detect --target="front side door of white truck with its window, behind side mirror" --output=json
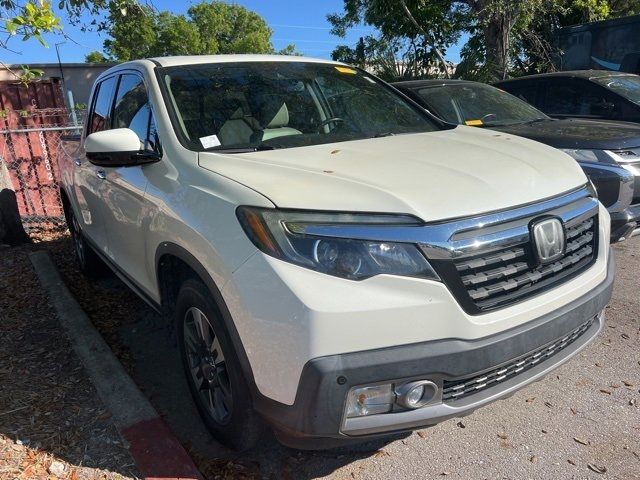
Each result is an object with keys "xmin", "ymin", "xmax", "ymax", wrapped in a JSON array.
[{"xmin": 102, "ymin": 71, "xmax": 162, "ymax": 293}]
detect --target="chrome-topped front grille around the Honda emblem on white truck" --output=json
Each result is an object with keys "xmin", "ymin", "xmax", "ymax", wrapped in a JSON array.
[{"xmin": 425, "ymin": 191, "xmax": 598, "ymax": 315}]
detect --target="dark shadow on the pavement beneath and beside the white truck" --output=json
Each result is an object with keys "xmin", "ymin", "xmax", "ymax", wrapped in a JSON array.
[{"xmin": 40, "ymin": 237, "xmax": 402, "ymax": 479}]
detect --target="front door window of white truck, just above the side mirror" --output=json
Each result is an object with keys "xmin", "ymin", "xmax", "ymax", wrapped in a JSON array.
[{"xmin": 113, "ymin": 74, "xmax": 159, "ymax": 152}]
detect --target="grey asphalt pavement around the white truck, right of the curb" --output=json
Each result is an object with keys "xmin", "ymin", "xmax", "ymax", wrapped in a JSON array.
[{"xmin": 43, "ymin": 234, "xmax": 640, "ymax": 479}]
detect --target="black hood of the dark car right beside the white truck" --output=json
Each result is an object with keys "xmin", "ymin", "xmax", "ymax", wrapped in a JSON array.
[{"xmin": 488, "ymin": 118, "xmax": 640, "ymax": 150}]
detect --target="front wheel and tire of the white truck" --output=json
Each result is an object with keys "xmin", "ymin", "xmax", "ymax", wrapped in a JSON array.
[{"xmin": 175, "ymin": 280, "xmax": 263, "ymax": 451}]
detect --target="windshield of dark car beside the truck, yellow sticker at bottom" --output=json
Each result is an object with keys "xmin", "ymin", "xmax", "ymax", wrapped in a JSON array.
[{"xmin": 416, "ymin": 83, "xmax": 549, "ymax": 127}]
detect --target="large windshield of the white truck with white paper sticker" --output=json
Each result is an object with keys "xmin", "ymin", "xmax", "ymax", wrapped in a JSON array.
[{"xmin": 162, "ymin": 62, "xmax": 442, "ymax": 152}]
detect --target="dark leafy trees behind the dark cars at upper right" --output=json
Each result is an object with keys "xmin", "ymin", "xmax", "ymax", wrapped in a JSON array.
[{"xmin": 328, "ymin": 0, "xmax": 640, "ymax": 81}]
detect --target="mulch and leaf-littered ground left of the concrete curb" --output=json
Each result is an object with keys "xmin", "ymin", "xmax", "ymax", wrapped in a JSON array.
[{"xmin": 0, "ymin": 240, "xmax": 137, "ymax": 480}]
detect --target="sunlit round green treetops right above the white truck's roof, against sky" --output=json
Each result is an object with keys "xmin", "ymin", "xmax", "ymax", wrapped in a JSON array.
[{"xmin": 104, "ymin": 1, "xmax": 288, "ymax": 61}]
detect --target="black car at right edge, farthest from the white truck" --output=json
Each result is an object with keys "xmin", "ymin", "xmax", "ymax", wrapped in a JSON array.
[{"xmin": 495, "ymin": 70, "xmax": 640, "ymax": 123}]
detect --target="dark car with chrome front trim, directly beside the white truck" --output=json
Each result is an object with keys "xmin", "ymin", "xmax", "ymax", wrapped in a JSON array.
[{"xmin": 394, "ymin": 80, "xmax": 640, "ymax": 242}]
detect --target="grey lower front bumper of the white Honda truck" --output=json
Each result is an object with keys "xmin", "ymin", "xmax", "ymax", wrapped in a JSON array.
[{"xmin": 254, "ymin": 255, "xmax": 615, "ymax": 448}]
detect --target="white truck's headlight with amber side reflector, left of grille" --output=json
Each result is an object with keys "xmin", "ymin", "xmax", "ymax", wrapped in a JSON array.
[{"xmin": 237, "ymin": 207, "xmax": 439, "ymax": 280}]
